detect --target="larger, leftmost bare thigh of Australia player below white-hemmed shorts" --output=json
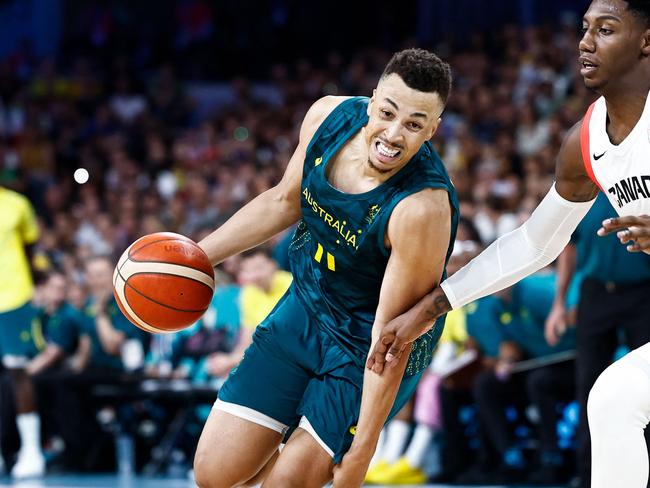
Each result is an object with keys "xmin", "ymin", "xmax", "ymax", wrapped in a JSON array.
[{"xmin": 194, "ymin": 409, "xmax": 282, "ymax": 488}]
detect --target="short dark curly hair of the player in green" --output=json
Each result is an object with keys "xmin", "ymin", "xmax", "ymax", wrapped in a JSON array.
[{"xmin": 381, "ymin": 48, "xmax": 451, "ymax": 103}]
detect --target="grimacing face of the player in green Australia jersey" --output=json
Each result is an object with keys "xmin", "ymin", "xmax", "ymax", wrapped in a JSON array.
[{"xmin": 365, "ymin": 74, "xmax": 444, "ymax": 173}]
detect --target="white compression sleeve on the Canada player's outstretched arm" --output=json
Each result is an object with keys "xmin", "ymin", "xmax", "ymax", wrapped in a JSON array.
[{"xmin": 440, "ymin": 184, "xmax": 595, "ymax": 308}]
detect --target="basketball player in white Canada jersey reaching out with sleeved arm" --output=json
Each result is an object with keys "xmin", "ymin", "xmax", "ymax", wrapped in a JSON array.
[{"xmin": 368, "ymin": 0, "xmax": 650, "ymax": 488}]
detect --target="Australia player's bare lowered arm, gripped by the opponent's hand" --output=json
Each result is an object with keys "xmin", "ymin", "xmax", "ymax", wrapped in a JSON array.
[{"xmin": 334, "ymin": 190, "xmax": 451, "ymax": 488}]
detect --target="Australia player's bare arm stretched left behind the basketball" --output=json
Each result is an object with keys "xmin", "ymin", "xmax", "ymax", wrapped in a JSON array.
[{"xmin": 199, "ymin": 97, "xmax": 346, "ymax": 265}]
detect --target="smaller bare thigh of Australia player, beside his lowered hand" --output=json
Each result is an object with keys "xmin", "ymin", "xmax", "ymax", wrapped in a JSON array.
[{"xmin": 262, "ymin": 428, "xmax": 334, "ymax": 488}]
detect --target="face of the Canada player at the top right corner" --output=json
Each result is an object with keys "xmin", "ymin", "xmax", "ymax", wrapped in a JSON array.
[{"xmin": 579, "ymin": 0, "xmax": 650, "ymax": 91}]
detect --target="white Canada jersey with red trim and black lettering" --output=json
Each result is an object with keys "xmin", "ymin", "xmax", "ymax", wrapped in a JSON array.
[{"xmin": 580, "ymin": 96, "xmax": 650, "ymax": 215}]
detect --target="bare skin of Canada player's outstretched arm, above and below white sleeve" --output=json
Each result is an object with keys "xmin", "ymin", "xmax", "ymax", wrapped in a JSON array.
[{"xmin": 366, "ymin": 121, "xmax": 596, "ymax": 374}]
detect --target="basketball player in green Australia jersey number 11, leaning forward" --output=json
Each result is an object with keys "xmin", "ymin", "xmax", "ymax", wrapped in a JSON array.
[{"xmin": 194, "ymin": 49, "xmax": 458, "ymax": 488}]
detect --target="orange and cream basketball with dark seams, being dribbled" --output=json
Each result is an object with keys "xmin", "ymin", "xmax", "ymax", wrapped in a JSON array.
[{"xmin": 113, "ymin": 232, "xmax": 214, "ymax": 333}]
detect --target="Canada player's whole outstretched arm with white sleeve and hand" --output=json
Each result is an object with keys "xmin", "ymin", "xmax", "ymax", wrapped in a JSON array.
[{"xmin": 368, "ymin": 122, "xmax": 598, "ymax": 373}]
